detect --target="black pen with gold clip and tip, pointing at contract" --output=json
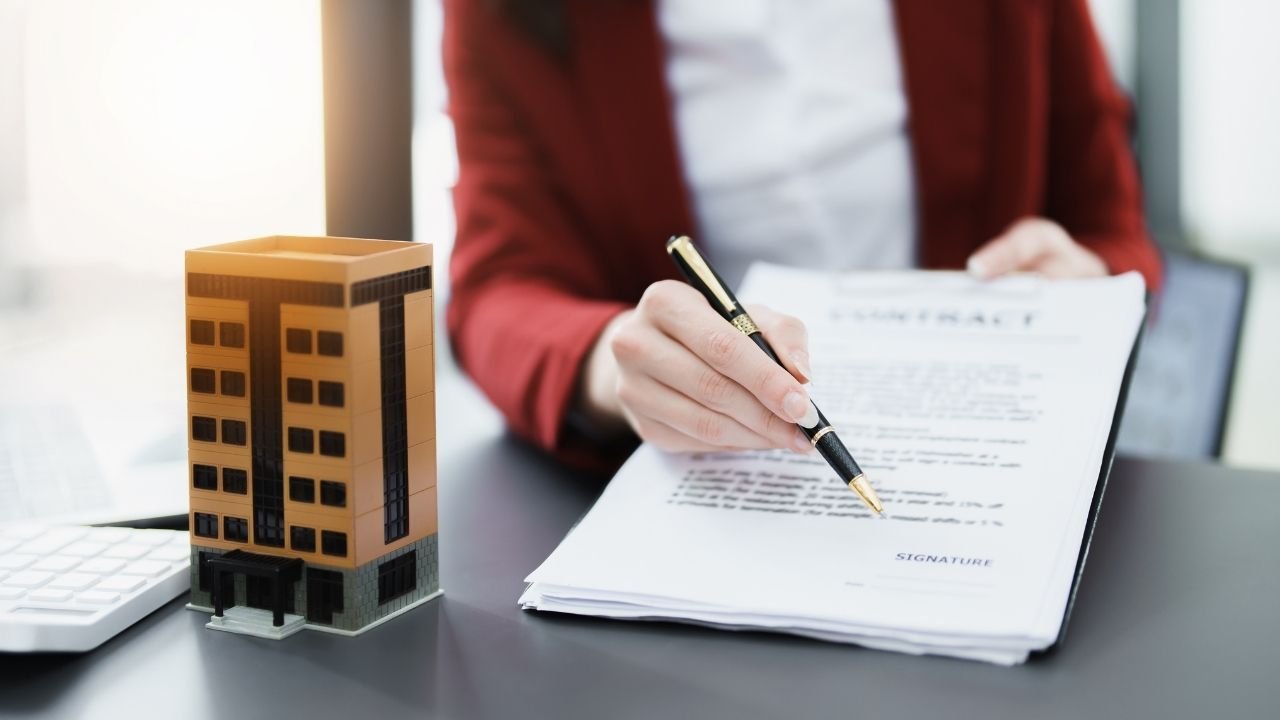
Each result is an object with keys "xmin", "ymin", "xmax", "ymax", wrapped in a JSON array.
[{"xmin": 667, "ymin": 236, "xmax": 884, "ymax": 514}]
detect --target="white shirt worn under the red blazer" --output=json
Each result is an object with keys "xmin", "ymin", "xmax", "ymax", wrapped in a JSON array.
[{"xmin": 658, "ymin": 0, "xmax": 915, "ymax": 286}]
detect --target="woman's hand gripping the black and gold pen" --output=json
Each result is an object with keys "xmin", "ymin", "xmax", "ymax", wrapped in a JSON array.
[{"xmin": 579, "ymin": 281, "xmax": 817, "ymax": 452}]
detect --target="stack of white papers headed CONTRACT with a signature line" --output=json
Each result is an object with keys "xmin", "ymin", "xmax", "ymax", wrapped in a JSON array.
[{"xmin": 520, "ymin": 265, "xmax": 1146, "ymax": 665}]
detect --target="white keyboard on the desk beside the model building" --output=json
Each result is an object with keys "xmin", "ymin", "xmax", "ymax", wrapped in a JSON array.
[{"xmin": 0, "ymin": 524, "xmax": 191, "ymax": 652}]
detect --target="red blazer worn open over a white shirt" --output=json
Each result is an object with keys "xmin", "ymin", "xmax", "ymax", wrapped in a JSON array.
[{"xmin": 444, "ymin": 0, "xmax": 1160, "ymax": 464}]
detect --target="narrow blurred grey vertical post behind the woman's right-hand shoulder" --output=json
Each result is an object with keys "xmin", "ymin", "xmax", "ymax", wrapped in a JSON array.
[{"xmin": 1134, "ymin": 0, "xmax": 1187, "ymax": 249}]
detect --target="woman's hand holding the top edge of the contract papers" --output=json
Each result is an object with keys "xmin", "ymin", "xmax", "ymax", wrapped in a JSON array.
[{"xmin": 968, "ymin": 218, "xmax": 1107, "ymax": 279}]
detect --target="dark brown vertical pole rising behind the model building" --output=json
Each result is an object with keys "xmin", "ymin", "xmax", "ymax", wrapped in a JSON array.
[{"xmin": 320, "ymin": 0, "xmax": 413, "ymax": 240}]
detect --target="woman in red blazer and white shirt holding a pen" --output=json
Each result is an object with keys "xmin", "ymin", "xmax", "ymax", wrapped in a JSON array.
[{"xmin": 444, "ymin": 0, "xmax": 1160, "ymax": 465}]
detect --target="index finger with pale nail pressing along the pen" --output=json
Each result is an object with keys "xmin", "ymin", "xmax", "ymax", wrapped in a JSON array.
[{"xmin": 637, "ymin": 282, "xmax": 817, "ymax": 427}]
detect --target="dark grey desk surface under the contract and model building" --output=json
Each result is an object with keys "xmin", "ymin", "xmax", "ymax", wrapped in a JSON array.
[{"xmin": 0, "ymin": 371, "xmax": 1280, "ymax": 720}]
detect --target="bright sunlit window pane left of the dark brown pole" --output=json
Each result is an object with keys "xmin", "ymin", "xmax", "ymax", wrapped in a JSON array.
[{"xmin": 10, "ymin": 0, "xmax": 325, "ymax": 274}]
